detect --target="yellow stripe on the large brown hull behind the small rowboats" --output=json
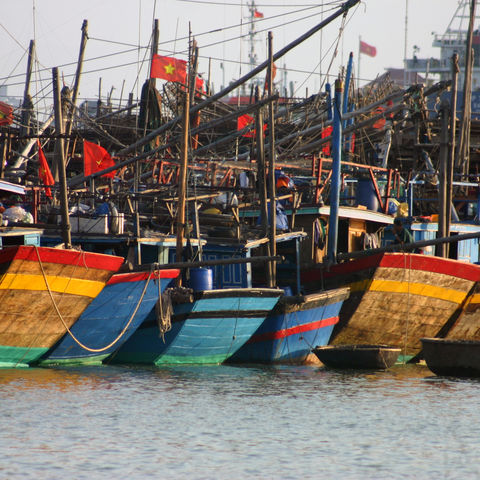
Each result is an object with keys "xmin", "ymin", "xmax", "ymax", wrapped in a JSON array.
[{"xmin": 349, "ymin": 280, "xmax": 467, "ymax": 303}]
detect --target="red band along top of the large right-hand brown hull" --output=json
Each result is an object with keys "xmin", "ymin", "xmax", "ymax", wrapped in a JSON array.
[{"xmin": 302, "ymin": 253, "xmax": 480, "ymax": 282}]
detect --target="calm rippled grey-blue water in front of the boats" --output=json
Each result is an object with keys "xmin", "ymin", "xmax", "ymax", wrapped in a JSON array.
[{"xmin": 0, "ymin": 366, "xmax": 480, "ymax": 480}]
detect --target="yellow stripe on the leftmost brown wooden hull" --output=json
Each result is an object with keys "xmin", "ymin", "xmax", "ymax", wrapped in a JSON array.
[{"xmin": 0, "ymin": 273, "xmax": 104, "ymax": 298}]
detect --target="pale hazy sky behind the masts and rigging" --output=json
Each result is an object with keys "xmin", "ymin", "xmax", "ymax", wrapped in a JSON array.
[{"xmin": 0, "ymin": 0, "xmax": 470, "ymax": 110}]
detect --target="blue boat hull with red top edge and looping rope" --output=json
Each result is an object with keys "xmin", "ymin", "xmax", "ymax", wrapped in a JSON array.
[{"xmin": 40, "ymin": 270, "xmax": 180, "ymax": 366}]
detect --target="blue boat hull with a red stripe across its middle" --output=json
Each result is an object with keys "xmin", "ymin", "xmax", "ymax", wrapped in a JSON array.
[{"xmin": 228, "ymin": 288, "xmax": 349, "ymax": 364}]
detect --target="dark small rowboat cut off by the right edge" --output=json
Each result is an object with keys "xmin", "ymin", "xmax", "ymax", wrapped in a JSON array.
[{"xmin": 422, "ymin": 338, "xmax": 480, "ymax": 377}]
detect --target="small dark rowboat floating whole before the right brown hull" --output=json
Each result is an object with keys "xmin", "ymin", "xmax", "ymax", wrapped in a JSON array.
[{"xmin": 313, "ymin": 345, "xmax": 401, "ymax": 370}]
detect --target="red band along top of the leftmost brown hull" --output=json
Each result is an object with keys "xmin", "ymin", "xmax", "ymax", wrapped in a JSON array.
[{"xmin": 0, "ymin": 245, "xmax": 124, "ymax": 272}]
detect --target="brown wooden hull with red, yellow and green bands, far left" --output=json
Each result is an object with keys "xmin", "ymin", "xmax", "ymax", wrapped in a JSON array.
[{"xmin": 0, "ymin": 246, "xmax": 123, "ymax": 367}]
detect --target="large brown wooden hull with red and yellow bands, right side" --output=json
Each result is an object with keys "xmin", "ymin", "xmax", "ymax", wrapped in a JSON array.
[{"xmin": 304, "ymin": 253, "xmax": 480, "ymax": 358}]
